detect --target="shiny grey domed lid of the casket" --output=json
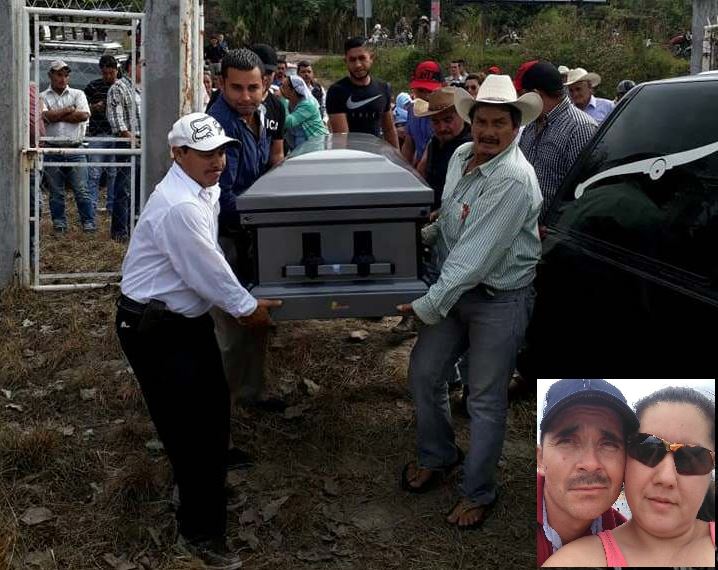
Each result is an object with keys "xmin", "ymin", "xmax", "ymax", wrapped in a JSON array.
[{"xmin": 237, "ymin": 133, "xmax": 434, "ymax": 212}]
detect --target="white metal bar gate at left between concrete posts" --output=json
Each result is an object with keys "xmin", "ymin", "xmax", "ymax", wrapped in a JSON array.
[{"xmin": 21, "ymin": 6, "xmax": 146, "ymax": 290}]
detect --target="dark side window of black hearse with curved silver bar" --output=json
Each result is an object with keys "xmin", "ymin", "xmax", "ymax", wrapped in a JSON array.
[{"xmin": 551, "ymin": 81, "xmax": 718, "ymax": 290}]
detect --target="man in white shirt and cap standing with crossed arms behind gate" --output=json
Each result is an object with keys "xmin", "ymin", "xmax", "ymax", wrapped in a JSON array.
[{"xmin": 40, "ymin": 59, "xmax": 96, "ymax": 234}]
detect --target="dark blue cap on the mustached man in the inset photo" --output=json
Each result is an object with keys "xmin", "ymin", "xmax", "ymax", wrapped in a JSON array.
[{"xmin": 541, "ymin": 378, "xmax": 640, "ymax": 435}]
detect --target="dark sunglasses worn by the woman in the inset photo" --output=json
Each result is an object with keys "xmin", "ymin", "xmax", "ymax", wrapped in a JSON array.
[{"xmin": 626, "ymin": 433, "xmax": 715, "ymax": 475}]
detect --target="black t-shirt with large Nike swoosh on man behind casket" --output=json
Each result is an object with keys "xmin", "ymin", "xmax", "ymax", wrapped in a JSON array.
[{"xmin": 327, "ymin": 77, "xmax": 391, "ymax": 137}]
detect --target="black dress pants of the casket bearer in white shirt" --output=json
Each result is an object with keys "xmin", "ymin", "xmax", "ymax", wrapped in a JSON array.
[{"xmin": 115, "ymin": 307, "xmax": 230, "ymax": 541}]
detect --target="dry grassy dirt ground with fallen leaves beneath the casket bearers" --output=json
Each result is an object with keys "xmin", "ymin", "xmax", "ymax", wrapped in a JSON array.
[{"xmin": 0, "ymin": 193, "xmax": 536, "ymax": 570}]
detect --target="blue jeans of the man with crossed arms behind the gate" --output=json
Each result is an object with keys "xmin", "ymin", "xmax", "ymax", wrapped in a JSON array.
[{"xmin": 44, "ymin": 154, "xmax": 95, "ymax": 229}]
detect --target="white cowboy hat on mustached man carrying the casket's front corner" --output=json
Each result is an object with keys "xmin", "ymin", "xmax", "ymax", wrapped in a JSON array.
[{"xmin": 454, "ymin": 75, "xmax": 543, "ymax": 125}]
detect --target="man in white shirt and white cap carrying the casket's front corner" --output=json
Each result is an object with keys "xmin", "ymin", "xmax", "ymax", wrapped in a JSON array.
[{"xmin": 115, "ymin": 113, "xmax": 281, "ymax": 569}]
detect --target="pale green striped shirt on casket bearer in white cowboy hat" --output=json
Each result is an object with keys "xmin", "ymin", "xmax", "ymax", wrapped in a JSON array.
[{"xmin": 412, "ymin": 140, "xmax": 541, "ymax": 325}]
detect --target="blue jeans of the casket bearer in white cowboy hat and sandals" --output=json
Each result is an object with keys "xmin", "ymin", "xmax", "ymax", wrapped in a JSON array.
[{"xmin": 409, "ymin": 286, "xmax": 534, "ymax": 505}]
